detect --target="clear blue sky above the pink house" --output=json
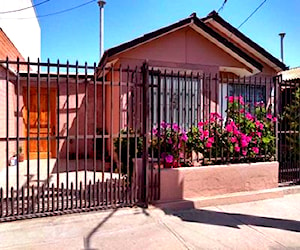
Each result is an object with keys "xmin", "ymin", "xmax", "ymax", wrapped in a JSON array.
[{"xmin": 33, "ymin": 0, "xmax": 300, "ymax": 67}]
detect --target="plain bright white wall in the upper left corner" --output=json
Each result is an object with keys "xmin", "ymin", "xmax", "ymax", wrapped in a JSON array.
[{"xmin": 0, "ymin": 0, "xmax": 41, "ymax": 61}]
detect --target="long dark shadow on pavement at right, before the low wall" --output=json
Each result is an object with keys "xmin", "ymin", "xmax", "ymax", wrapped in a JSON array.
[{"xmin": 165, "ymin": 209, "xmax": 300, "ymax": 233}]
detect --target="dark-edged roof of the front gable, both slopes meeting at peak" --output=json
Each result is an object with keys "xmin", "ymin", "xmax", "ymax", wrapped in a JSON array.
[{"xmin": 99, "ymin": 13, "xmax": 263, "ymax": 71}]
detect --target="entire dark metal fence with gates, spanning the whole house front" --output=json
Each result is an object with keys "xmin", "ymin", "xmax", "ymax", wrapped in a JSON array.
[{"xmin": 0, "ymin": 60, "xmax": 299, "ymax": 220}]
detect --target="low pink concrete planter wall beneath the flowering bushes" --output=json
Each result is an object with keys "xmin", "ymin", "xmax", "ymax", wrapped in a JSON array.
[{"xmin": 160, "ymin": 162, "xmax": 279, "ymax": 201}]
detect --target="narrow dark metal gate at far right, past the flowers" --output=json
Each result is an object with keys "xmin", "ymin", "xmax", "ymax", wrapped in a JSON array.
[{"xmin": 275, "ymin": 75, "xmax": 300, "ymax": 184}]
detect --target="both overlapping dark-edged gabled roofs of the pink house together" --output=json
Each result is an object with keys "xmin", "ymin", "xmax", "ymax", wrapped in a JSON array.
[{"xmin": 99, "ymin": 11, "xmax": 286, "ymax": 71}]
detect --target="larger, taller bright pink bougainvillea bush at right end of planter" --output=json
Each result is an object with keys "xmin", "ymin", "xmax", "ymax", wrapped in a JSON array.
[{"xmin": 222, "ymin": 96, "xmax": 276, "ymax": 160}]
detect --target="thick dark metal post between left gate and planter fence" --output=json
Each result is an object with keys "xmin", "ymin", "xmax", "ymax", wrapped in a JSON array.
[{"xmin": 141, "ymin": 62, "xmax": 149, "ymax": 207}]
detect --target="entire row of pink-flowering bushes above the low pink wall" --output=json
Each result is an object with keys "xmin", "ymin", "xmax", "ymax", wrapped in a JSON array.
[{"xmin": 151, "ymin": 96, "xmax": 276, "ymax": 168}]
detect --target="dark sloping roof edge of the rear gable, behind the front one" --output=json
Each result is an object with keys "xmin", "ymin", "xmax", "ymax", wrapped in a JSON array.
[{"xmin": 201, "ymin": 11, "xmax": 287, "ymax": 70}]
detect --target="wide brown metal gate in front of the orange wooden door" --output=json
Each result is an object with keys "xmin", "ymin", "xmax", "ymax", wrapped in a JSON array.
[{"xmin": 0, "ymin": 59, "xmax": 147, "ymax": 221}]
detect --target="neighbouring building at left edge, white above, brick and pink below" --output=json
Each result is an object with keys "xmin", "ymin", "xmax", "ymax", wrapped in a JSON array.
[{"xmin": 0, "ymin": 0, "xmax": 41, "ymax": 170}]
